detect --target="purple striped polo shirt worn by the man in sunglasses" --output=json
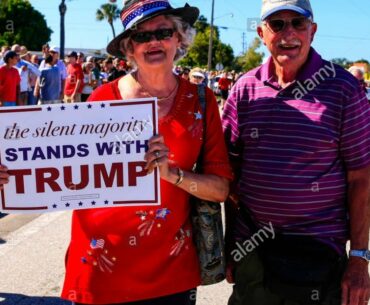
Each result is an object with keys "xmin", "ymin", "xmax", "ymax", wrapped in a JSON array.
[{"xmin": 223, "ymin": 49, "xmax": 370, "ymax": 251}]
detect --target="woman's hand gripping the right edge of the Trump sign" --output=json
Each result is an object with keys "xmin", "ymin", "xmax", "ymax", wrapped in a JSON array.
[{"xmin": 144, "ymin": 135, "xmax": 171, "ymax": 180}]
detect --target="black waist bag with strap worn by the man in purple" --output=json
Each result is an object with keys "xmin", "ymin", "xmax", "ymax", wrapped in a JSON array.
[{"xmin": 239, "ymin": 205, "xmax": 347, "ymax": 305}]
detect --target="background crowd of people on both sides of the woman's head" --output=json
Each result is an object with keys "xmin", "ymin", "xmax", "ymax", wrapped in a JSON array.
[{"xmin": 0, "ymin": 44, "xmax": 242, "ymax": 107}]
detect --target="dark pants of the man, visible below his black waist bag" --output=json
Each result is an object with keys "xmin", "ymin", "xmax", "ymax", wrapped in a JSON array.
[{"xmin": 228, "ymin": 251, "xmax": 341, "ymax": 305}]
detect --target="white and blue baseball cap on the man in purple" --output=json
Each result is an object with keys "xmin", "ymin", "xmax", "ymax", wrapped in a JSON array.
[{"xmin": 261, "ymin": 0, "xmax": 313, "ymax": 20}]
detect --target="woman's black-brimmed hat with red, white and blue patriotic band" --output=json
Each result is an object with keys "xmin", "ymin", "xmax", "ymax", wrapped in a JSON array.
[{"xmin": 107, "ymin": 0, "xmax": 199, "ymax": 56}]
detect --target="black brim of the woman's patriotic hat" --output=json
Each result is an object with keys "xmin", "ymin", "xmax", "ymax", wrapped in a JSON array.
[{"xmin": 107, "ymin": 6, "xmax": 199, "ymax": 57}]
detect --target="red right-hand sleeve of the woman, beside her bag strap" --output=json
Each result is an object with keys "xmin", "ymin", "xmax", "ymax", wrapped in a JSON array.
[{"xmin": 203, "ymin": 88, "xmax": 233, "ymax": 180}]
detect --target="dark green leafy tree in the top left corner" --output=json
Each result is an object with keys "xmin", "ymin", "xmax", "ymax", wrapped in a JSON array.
[{"xmin": 0, "ymin": 0, "xmax": 53, "ymax": 50}]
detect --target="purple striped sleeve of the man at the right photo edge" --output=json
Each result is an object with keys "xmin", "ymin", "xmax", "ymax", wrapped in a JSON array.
[{"xmin": 340, "ymin": 84, "xmax": 370, "ymax": 170}]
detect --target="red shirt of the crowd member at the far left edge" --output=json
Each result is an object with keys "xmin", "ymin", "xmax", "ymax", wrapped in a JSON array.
[{"xmin": 0, "ymin": 65, "xmax": 21, "ymax": 102}]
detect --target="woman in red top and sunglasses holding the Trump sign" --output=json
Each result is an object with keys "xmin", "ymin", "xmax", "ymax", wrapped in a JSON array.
[{"xmin": 0, "ymin": 0, "xmax": 231, "ymax": 305}]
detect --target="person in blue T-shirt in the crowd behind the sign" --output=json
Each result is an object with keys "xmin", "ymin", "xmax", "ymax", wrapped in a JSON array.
[{"xmin": 34, "ymin": 53, "xmax": 61, "ymax": 105}]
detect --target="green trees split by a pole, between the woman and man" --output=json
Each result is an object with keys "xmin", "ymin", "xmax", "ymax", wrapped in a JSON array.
[{"xmin": 179, "ymin": 16, "xmax": 234, "ymax": 67}]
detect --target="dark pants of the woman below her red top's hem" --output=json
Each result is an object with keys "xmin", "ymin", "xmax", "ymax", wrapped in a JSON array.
[{"xmin": 76, "ymin": 288, "xmax": 197, "ymax": 305}]
